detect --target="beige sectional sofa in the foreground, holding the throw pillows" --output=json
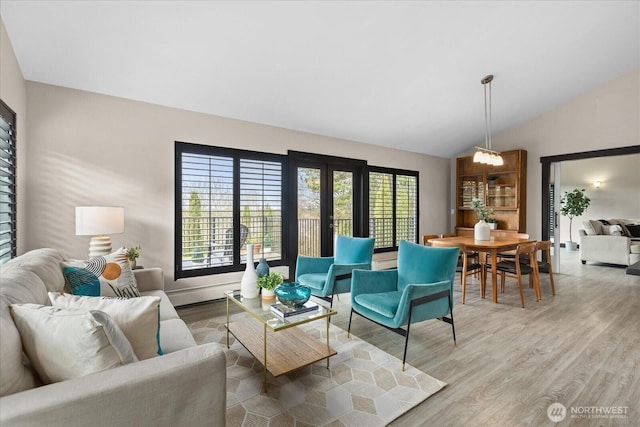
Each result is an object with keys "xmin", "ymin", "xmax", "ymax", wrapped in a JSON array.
[{"xmin": 0, "ymin": 249, "xmax": 226, "ymax": 427}]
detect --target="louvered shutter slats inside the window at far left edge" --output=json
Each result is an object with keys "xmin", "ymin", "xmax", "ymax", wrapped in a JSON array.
[{"xmin": 0, "ymin": 100, "xmax": 17, "ymax": 264}]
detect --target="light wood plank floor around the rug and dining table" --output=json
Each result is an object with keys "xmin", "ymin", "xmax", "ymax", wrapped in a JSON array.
[{"xmin": 178, "ymin": 253, "xmax": 640, "ymax": 427}]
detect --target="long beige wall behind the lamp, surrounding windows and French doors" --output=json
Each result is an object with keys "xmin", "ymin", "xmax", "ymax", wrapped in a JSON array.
[{"xmin": 26, "ymin": 82, "xmax": 449, "ymax": 304}]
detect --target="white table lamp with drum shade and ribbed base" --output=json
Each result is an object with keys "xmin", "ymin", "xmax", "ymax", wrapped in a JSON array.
[{"xmin": 76, "ymin": 206, "xmax": 124, "ymax": 258}]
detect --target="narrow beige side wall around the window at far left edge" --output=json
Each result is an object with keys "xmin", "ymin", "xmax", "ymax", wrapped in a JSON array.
[{"xmin": 0, "ymin": 19, "xmax": 27, "ymax": 253}]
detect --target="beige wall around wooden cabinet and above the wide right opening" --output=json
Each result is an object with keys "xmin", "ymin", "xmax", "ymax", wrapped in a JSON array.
[{"xmin": 450, "ymin": 68, "xmax": 640, "ymax": 242}]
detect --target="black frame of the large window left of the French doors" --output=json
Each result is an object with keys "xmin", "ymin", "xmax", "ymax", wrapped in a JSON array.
[{"xmin": 174, "ymin": 141, "xmax": 288, "ymax": 280}]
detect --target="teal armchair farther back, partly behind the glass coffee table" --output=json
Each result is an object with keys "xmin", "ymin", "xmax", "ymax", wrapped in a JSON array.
[{"xmin": 296, "ymin": 235, "xmax": 375, "ymax": 305}]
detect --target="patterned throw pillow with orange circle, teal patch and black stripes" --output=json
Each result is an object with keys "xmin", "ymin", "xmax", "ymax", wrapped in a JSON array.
[{"xmin": 62, "ymin": 248, "xmax": 140, "ymax": 298}]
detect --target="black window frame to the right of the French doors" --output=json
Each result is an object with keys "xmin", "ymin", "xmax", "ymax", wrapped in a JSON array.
[{"xmin": 365, "ymin": 166, "xmax": 420, "ymax": 253}]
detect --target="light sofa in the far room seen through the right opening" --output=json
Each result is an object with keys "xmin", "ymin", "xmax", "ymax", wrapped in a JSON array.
[{"xmin": 580, "ymin": 218, "xmax": 640, "ymax": 266}]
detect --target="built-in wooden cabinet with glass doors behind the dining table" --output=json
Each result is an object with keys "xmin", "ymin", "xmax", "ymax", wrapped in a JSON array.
[{"xmin": 456, "ymin": 150, "xmax": 527, "ymax": 234}]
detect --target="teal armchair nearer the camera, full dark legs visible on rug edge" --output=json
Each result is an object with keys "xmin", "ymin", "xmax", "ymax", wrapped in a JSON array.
[{"xmin": 347, "ymin": 241, "xmax": 460, "ymax": 370}]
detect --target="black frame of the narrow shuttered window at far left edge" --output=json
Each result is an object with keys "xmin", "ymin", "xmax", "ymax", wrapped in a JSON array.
[{"xmin": 0, "ymin": 99, "xmax": 18, "ymax": 264}]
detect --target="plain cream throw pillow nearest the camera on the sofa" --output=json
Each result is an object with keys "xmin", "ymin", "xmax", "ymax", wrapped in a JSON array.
[{"xmin": 11, "ymin": 304, "xmax": 138, "ymax": 384}]
